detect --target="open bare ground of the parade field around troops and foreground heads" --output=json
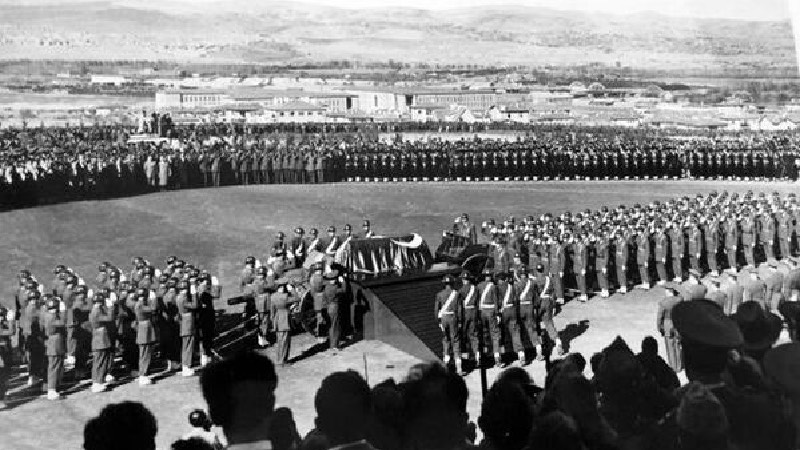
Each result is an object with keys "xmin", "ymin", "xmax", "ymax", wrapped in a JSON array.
[{"xmin": 0, "ymin": 181, "xmax": 798, "ymax": 449}]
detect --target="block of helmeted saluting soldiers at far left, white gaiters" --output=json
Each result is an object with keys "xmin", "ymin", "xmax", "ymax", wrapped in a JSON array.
[{"xmin": 0, "ymin": 257, "xmax": 221, "ymax": 406}]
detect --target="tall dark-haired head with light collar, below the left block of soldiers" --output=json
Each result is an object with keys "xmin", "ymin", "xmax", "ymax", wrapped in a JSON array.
[{"xmin": 200, "ymin": 352, "xmax": 278, "ymax": 450}]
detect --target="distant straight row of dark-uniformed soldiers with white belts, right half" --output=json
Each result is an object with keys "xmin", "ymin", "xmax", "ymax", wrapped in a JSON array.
[{"xmin": 344, "ymin": 149, "xmax": 800, "ymax": 181}]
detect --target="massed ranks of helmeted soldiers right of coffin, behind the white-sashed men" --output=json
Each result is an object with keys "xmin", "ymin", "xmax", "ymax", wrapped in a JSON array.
[{"xmin": 481, "ymin": 192, "xmax": 800, "ymax": 303}]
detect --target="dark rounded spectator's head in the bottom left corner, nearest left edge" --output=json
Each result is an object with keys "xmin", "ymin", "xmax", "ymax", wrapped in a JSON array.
[{"xmin": 83, "ymin": 402, "xmax": 158, "ymax": 450}]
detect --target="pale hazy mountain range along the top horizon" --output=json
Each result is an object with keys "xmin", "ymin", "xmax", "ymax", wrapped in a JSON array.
[{"xmin": 0, "ymin": 0, "xmax": 797, "ymax": 73}]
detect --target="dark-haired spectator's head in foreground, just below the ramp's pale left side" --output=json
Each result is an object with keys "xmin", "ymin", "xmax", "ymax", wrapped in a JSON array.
[{"xmin": 314, "ymin": 370, "xmax": 373, "ymax": 450}]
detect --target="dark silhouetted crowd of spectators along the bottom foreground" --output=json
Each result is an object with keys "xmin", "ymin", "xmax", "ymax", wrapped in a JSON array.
[{"xmin": 84, "ymin": 326, "xmax": 800, "ymax": 450}]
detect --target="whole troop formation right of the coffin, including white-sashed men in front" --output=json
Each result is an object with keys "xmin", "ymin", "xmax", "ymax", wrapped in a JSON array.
[{"xmin": 435, "ymin": 191, "xmax": 800, "ymax": 371}]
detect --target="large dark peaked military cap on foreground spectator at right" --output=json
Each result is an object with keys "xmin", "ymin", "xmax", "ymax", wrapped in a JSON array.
[{"xmin": 672, "ymin": 300, "xmax": 744, "ymax": 348}]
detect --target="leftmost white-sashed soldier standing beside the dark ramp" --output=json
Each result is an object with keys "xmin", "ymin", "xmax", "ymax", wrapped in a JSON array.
[{"xmin": 434, "ymin": 275, "xmax": 463, "ymax": 373}]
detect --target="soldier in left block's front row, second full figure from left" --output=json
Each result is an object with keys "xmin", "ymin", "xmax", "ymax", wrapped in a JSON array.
[{"xmin": 89, "ymin": 292, "xmax": 115, "ymax": 393}]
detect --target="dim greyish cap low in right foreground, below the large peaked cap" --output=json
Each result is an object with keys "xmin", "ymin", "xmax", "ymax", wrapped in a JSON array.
[{"xmin": 676, "ymin": 383, "xmax": 728, "ymax": 438}]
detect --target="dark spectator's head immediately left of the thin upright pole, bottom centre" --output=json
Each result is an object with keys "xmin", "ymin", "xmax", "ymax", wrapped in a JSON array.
[{"xmin": 400, "ymin": 363, "xmax": 471, "ymax": 450}]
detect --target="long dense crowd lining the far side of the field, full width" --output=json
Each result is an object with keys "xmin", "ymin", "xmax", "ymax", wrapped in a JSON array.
[{"xmin": 0, "ymin": 127, "xmax": 800, "ymax": 209}]
